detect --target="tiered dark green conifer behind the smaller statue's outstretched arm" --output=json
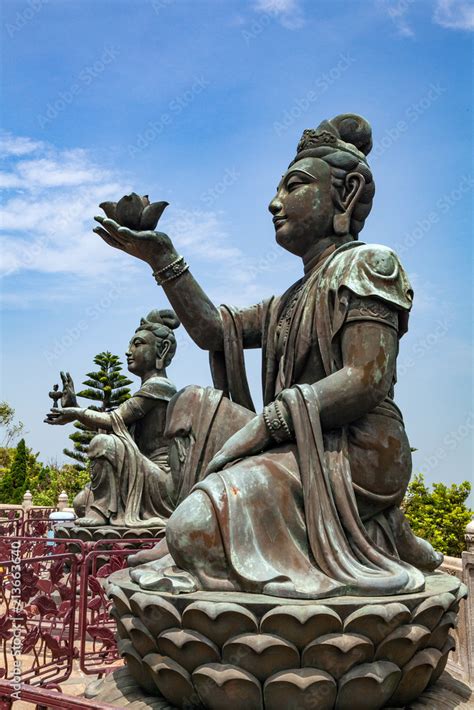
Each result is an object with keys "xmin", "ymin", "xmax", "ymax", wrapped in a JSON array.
[{"xmin": 63, "ymin": 351, "xmax": 132, "ymax": 471}]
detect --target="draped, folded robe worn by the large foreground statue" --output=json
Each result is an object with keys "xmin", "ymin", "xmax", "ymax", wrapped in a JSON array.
[{"xmin": 167, "ymin": 242, "xmax": 424, "ymax": 599}]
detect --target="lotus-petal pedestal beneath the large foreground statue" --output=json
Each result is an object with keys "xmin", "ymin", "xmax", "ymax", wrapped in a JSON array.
[{"xmin": 101, "ymin": 570, "xmax": 466, "ymax": 710}]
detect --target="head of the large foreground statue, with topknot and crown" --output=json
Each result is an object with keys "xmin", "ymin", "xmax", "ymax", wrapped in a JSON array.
[{"xmin": 269, "ymin": 114, "xmax": 375, "ymax": 256}]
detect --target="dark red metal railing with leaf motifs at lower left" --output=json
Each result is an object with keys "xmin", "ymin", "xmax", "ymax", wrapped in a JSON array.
[{"xmin": 0, "ymin": 536, "xmax": 156, "ymax": 710}]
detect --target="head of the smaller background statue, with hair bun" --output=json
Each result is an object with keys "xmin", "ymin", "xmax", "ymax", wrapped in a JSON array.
[{"xmin": 126, "ymin": 309, "xmax": 180, "ymax": 376}]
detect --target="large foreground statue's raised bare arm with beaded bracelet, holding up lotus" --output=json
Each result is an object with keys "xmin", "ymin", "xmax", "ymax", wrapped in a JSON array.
[{"xmin": 94, "ymin": 217, "xmax": 223, "ymax": 350}]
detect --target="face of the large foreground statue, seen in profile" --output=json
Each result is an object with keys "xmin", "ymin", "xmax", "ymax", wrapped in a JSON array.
[{"xmin": 268, "ymin": 158, "xmax": 335, "ymax": 256}]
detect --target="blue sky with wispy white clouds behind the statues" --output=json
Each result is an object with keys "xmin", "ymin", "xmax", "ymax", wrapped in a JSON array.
[{"xmin": 0, "ymin": 0, "xmax": 474, "ymax": 500}]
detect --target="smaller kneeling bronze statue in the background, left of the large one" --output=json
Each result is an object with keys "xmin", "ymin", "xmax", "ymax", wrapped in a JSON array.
[{"xmin": 45, "ymin": 310, "xmax": 179, "ymax": 536}]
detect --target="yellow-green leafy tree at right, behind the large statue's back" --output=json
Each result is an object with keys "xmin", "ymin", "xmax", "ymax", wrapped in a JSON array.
[{"xmin": 402, "ymin": 473, "xmax": 473, "ymax": 557}]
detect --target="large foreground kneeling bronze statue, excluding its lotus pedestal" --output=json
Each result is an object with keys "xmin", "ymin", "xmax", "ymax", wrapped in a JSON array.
[{"xmin": 95, "ymin": 114, "xmax": 441, "ymax": 599}]
